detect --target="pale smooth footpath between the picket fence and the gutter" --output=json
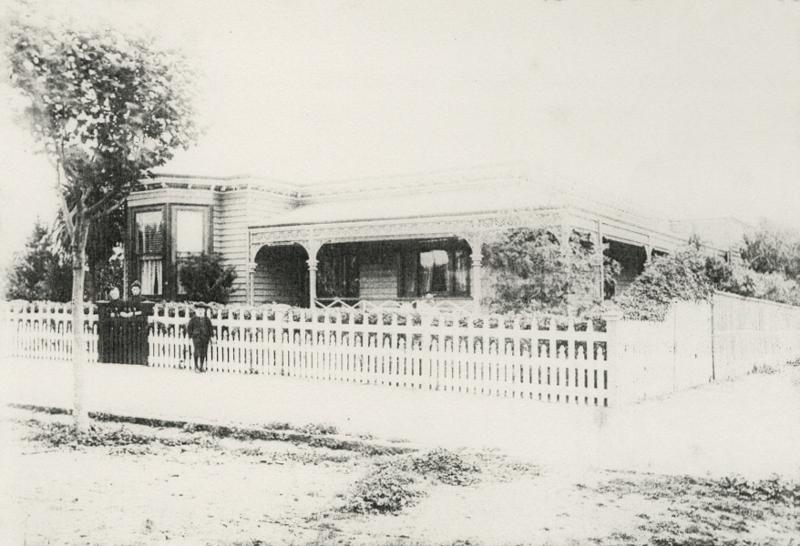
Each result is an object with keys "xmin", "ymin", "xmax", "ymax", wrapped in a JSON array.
[{"xmin": 0, "ymin": 359, "xmax": 800, "ymax": 479}]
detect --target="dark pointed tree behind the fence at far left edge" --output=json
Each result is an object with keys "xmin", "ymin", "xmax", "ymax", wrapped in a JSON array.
[{"xmin": 6, "ymin": 221, "xmax": 72, "ymax": 301}]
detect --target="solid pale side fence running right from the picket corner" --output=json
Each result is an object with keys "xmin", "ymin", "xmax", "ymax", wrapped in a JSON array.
[{"xmin": 607, "ymin": 292, "xmax": 800, "ymax": 404}]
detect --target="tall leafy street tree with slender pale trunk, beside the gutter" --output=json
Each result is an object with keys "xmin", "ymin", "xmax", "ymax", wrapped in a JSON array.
[{"xmin": 7, "ymin": 20, "xmax": 197, "ymax": 429}]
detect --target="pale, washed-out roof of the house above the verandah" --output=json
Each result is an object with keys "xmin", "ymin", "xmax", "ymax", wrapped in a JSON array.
[{"xmin": 142, "ymin": 167, "xmax": 708, "ymax": 236}]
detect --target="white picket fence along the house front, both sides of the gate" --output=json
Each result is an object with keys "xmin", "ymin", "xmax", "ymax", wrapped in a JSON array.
[{"xmin": 2, "ymin": 302, "xmax": 610, "ymax": 405}]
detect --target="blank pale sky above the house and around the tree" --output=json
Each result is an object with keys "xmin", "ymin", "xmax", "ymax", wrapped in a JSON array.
[{"xmin": 0, "ymin": 0, "xmax": 800, "ymax": 270}]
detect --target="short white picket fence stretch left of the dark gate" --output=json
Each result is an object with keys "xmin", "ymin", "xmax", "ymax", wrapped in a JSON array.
[{"xmin": 0, "ymin": 301, "xmax": 97, "ymax": 362}]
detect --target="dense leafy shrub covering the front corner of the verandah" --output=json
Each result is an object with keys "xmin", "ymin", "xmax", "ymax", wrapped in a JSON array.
[{"xmin": 483, "ymin": 228, "xmax": 619, "ymax": 313}]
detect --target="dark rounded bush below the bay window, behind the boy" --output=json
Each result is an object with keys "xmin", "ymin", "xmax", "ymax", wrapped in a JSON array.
[{"xmin": 180, "ymin": 253, "xmax": 236, "ymax": 303}]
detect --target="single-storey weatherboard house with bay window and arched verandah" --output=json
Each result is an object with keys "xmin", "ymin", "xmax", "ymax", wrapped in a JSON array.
[{"xmin": 126, "ymin": 169, "xmax": 741, "ymax": 308}]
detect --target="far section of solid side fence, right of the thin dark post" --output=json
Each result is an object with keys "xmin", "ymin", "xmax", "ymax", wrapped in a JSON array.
[{"xmin": 713, "ymin": 293, "xmax": 800, "ymax": 379}]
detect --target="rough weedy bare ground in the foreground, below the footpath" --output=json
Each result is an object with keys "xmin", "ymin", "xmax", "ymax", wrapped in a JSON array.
[{"xmin": 0, "ymin": 407, "xmax": 800, "ymax": 546}]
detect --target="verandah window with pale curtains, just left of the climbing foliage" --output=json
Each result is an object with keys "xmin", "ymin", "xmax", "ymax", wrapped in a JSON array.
[{"xmin": 398, "ymin": 241, "xmax": 471, "ymax": 297}]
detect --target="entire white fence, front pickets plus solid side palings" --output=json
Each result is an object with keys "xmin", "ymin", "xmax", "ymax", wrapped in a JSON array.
[{"xmin": 6, "ymin": 294, "xmax": 800, "ymax": 406}]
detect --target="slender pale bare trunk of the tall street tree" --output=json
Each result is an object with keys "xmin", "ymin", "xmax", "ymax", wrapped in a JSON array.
[{"xmin": 72, "ymin": 219, "xmax": 89, "ymax": 430}]
